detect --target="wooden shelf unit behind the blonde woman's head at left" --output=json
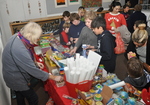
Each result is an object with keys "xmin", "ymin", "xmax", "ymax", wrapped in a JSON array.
[{"xmin": 9, "ymin": 16, "xmax": 62, "ymax": 36}]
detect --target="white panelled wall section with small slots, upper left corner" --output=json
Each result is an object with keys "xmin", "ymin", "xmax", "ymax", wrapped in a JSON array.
[{"xmin": 0, "ymin": 0, "xmax": 47, "ymax": 45}]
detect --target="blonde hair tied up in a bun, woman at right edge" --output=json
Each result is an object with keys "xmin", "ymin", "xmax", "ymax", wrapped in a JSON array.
[{"xmin": 132, "ymin": 24, "xmax": 148, "ymax": 44}]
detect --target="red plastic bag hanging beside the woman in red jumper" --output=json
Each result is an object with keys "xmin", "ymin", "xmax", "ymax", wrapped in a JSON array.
[{"xmin": 114, "ymin": 32, "xmax": 125, "ymax": 54}]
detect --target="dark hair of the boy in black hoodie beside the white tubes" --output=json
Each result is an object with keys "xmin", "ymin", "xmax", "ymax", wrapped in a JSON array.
[{"xmin": 91, "ymin": 16, "xmax": 106, "ymax": 30}]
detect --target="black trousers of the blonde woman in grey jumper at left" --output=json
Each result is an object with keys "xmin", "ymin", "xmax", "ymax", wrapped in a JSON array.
[{"xmin": 15, "ymin": 89, "xmax": 38, "ymax": 105}]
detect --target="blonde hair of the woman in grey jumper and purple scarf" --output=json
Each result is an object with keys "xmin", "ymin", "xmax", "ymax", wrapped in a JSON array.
[{"xmin": 20, "ymin": 22, "xmax": 42, "ymax": 44}]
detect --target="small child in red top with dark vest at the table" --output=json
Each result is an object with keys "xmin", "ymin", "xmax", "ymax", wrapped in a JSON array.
[{"xmin": 60, "ymin": 23, "xmax": 71, "ymax": 48}]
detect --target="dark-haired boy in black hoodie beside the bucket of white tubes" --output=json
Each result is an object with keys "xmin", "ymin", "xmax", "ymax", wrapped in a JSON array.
[{"xmin": 88, "ymin": 17, "xmax": 116, "ymax": 73}]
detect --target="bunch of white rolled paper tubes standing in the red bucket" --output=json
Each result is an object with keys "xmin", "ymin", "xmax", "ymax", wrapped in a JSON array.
[{"xmin": 64, "ymin": 53, "xmax": 97, "ymax": 84}]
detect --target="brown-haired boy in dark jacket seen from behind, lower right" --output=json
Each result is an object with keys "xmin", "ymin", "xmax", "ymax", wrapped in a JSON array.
[{"xmin": 124, "ymin": 57, "xmax": 150, "ymax": 90}]
